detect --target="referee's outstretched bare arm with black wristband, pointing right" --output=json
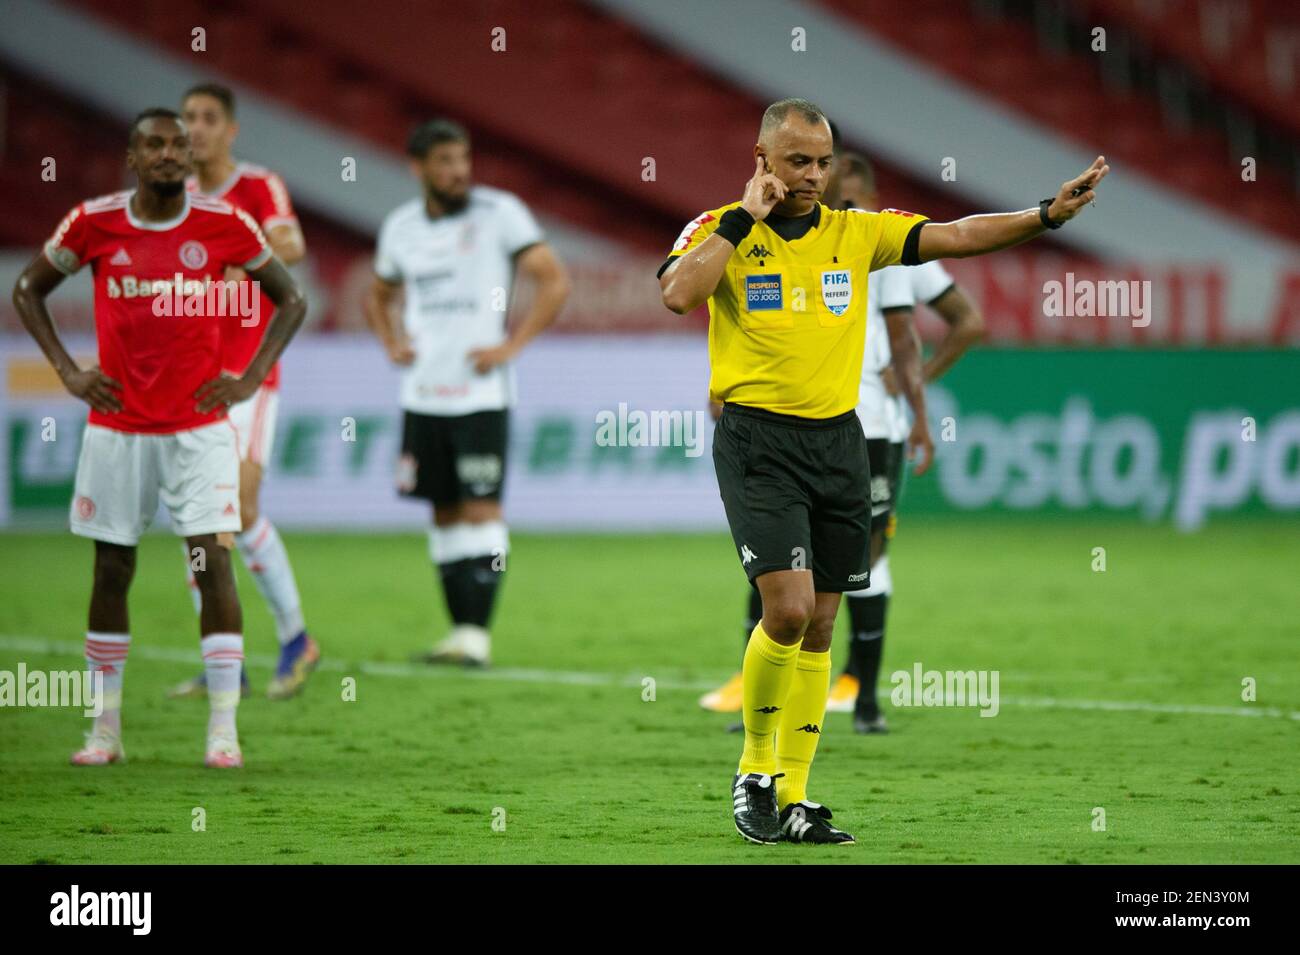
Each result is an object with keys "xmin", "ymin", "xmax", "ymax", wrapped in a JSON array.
[{"xmin": 902, "ymin": 156, "xmax": 1110, "ymax": 265}]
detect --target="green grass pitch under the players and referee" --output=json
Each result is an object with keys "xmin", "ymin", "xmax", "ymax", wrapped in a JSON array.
[{"xmin": 0, "ymin": 515, "xmax": 1300, "ymax": 863}]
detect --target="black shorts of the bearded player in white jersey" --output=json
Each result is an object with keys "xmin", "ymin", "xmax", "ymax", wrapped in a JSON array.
[{"xmin": 398, "ymin": 409, "xmax": 510, "ymax": 505}]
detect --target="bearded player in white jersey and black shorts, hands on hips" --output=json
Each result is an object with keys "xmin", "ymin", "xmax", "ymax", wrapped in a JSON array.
[{"xmin": 365, "ymin": 120, "xmax": 569, "ymax": 665}]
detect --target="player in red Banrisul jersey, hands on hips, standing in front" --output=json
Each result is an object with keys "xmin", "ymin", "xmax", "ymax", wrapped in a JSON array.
[{"xmin": 13, "ymin": 108, "xmax": 307, "ymax": 768}]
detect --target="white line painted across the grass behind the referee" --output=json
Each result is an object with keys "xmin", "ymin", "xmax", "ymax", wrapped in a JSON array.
[{"xmin": 0, "ymin": 634, "xmax": 1300, "ymax": 721}]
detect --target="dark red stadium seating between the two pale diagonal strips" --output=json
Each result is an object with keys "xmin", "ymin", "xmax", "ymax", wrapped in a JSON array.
[{"xmin": 58, "ymin": 0, "xmax": 974, "ymax": 244}]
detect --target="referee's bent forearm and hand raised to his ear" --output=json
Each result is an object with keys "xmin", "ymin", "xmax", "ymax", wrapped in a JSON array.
[{"xmin": 659, "ymin": 156, "xmax": 785, "ymax": 314}]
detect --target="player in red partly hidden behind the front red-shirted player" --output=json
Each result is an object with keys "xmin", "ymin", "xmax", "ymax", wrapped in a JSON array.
[{"xmin": 172, "ymin": 83, "xmax": 320, "ymax": 699}]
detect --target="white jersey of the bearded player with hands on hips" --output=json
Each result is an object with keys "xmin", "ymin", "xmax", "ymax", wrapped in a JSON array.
[{"xmin": 374, "ymin": 186, "xmax": 542, "ymax": 414}]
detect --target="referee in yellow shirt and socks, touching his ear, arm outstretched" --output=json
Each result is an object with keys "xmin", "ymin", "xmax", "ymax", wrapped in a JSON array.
[{"xmin": 659, "ymin": 99, "xmax": 1109, "ymax": 845}]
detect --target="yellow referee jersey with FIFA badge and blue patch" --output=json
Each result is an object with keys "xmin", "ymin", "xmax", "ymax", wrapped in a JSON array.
[{"xmin": 670, "ymin": 203, "xmax": 926, "ymax": 418}]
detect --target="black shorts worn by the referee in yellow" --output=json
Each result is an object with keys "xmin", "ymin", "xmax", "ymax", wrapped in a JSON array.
[{"xmin": 714, "ymin": 404, "xmax": 871, "ymax": 592}]
